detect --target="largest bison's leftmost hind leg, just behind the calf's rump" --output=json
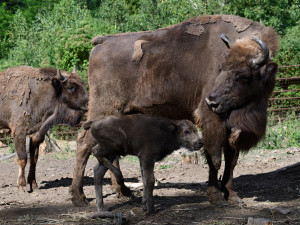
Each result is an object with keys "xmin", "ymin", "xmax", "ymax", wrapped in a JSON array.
[{"xmin": 69, "ymin": 130, "xmax": 96, "ymax": 206}]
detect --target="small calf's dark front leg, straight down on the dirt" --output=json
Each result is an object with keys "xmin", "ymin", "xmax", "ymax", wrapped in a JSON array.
[{"xmin": 140, "ymin": 159, "xmax": 155, "ymax": 213}]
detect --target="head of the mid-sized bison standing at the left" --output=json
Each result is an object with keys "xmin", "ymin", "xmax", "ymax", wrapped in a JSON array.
[{"xmin": 52, "ymin": 69, "xmax": 88, "ymax": 111}]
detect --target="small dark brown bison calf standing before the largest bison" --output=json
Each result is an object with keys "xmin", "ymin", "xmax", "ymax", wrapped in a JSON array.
[{"xmin": 83, "ymin": 114, "xmax": 203, "ymax": 213}]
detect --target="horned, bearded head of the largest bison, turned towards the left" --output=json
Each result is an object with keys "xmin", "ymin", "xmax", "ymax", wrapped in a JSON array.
[{"xmin": 205, "ymin": 35, "xmax": 277, "ymax": 114}]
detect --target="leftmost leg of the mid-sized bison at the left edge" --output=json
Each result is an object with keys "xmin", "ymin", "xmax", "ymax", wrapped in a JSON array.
[{"xmin": 14, "ymin": 133, "xmax": 27, "ymax": 192}]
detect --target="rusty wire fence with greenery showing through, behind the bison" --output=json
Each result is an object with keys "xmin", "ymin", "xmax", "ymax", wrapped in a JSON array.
[{"xmin": 0, "ymin": 64, "xmax": 300, "ymax": 142}]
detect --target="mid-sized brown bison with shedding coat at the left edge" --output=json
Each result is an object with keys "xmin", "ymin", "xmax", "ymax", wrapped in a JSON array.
[{"xmin": 0, "ymin": 66, "xmax": 88, "ymax": 191}]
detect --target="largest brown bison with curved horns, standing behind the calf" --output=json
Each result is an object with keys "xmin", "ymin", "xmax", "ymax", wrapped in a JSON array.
[{"xmin": 70, "ymin": 15, "xmax": 278, "ymax": 204}]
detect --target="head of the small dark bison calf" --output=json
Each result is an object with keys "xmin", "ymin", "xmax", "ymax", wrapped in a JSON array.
[{"xmin": 176, "ymin": 120, "xmax": 203, "ymax": 151}]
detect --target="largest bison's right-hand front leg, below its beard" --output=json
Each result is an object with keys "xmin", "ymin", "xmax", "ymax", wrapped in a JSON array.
[{"xmin": 221, "ymin": 145, "xmax": 242, "ymax": 204}]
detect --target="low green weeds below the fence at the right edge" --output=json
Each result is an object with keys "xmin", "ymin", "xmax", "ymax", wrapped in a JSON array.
[{"xmin": 256, "ymin": 113, "xmax": 300, "ymax": 150}]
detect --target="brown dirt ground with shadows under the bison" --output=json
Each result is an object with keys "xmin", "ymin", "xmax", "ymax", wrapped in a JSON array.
[{"xmin": 0, "ymin": 142, "xmax": 300, "ymax": 225}]
